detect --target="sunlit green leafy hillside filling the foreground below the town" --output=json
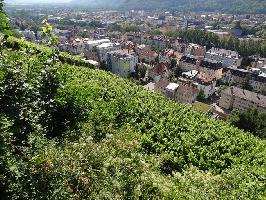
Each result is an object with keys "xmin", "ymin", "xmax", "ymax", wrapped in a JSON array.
[{"xmin": 0, "ymin": 38, "xmax": 266, "ymax": 199}]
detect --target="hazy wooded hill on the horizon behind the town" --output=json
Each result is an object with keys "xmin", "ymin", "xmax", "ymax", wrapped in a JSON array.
[{"xmin": 72, "ymin": 0, "xmax": 266, "ymax": 13}]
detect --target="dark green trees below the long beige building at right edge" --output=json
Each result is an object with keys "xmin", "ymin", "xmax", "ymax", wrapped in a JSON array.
[{"xmin": 228, "ymin": 109, "xmax": 266, "ymax": 139}]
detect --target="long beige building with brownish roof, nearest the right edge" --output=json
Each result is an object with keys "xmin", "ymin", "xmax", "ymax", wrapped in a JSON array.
[{"xmin": 219, "ymin": 87, "xmax": 266, "ymax": 112}]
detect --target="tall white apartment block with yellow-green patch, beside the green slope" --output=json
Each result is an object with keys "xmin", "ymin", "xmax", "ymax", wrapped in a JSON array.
[{"xmin": 107, "ymin": 51, "xmax": 138, "ymax": 78}]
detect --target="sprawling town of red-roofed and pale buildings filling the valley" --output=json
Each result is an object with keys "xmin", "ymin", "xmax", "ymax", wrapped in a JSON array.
[{"xmin": 7, "ymin": 6, "xmax": 266, "ymax": 118}]
